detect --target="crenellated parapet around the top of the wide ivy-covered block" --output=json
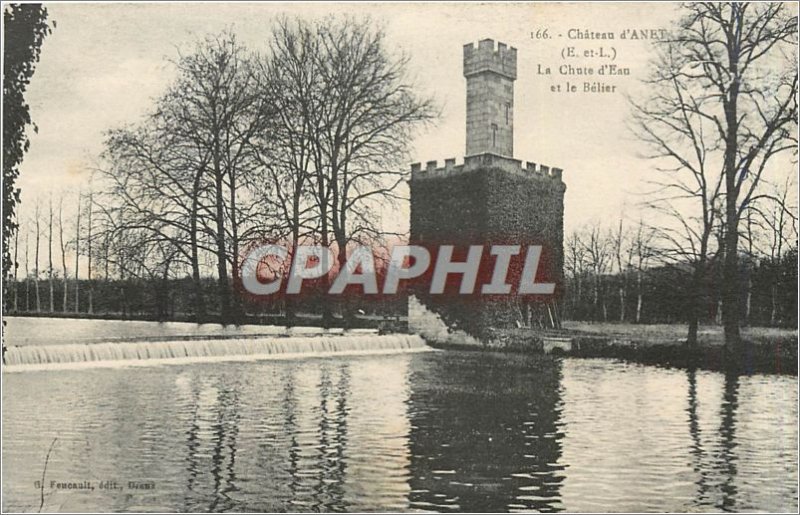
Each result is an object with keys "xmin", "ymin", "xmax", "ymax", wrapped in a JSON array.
[{"xmin": 411, "ymin": 154, "xmax": 563, "ymax": 182}]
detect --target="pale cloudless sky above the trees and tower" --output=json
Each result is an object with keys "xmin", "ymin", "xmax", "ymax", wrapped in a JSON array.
[{"xmin": 14, "ymin": 3, "xmax": 792, "ymax": 245}]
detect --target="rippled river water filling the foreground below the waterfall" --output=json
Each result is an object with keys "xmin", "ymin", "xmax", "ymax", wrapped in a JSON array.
[{"xmin": 2, "ymin": 352, "xmax": 798, "ymax": 512}]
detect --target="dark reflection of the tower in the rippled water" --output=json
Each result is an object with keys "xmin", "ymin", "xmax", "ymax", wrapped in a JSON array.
[{"xmin": 409, "ymin": 355, "xmax": 564, "ymax": 512}]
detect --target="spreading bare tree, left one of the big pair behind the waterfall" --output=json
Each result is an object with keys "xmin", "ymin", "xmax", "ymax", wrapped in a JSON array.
[{"xmin": 98, "ymin": 33, "xmax": 274, "ymax": 323}]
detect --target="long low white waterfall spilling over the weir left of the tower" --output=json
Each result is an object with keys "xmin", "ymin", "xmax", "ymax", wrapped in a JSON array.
[{"xmin": 5, "ymin": 334, "xmax": 430, "ymax": 372}]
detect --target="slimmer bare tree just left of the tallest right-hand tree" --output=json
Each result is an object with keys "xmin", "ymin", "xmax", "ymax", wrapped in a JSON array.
[{"xmin": 632, "ymin": 37, "xmax": 723, "ymax": 347}]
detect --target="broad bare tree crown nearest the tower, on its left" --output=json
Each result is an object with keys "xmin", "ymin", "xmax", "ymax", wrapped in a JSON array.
[{"xmin": 267, "ymin": 18, "xmax": 435, "ymax": 324}]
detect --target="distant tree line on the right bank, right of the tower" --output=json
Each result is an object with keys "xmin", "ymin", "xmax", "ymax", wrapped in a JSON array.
[{"xmin": 562, "ymin": 216, "xmax": 798, "ymax": 327}]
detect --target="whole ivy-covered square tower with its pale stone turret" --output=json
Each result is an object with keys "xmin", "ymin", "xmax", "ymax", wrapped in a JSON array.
[{"xmin": 409, "ymin": 39, "xmax": 566, "ymax": 339}]
